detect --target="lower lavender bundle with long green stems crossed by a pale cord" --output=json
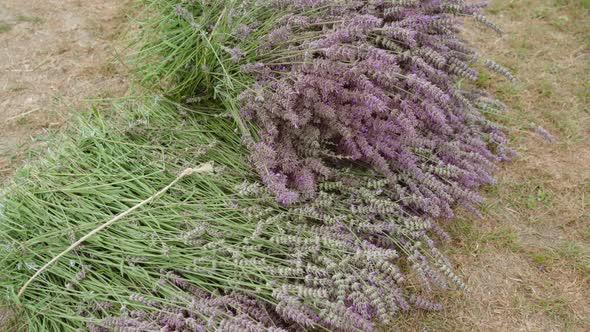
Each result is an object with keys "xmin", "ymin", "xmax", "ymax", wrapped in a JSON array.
[{"xmin": 0, "ymin": 102, "xmax": 462, "ymax": 331}]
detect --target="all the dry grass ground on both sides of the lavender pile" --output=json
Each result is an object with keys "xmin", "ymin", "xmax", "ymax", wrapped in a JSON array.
[{"xmin": 0, "ymin": 0, "xmax": 590, "ymax": 331}]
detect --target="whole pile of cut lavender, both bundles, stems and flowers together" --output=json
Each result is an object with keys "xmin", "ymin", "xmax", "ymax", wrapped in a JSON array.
[{"xmin": 0, "ymin": 0, "xmax": 513, "ymax": 331}]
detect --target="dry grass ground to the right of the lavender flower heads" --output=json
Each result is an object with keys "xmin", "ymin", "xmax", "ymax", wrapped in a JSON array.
[{"xmin": 399, "ymin": 0, "xmax": 590, "ymax": 331}]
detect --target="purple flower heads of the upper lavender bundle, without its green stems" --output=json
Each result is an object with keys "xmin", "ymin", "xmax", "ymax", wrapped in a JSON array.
[{"xmin": 239, "ymin": 1, "xmax": 510, "ymax": 213}]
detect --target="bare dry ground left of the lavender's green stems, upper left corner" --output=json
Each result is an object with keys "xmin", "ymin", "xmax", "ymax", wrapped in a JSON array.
[{"xmin": 0, "ymin": 0, "xmax": 127, "ymax": 178}]
